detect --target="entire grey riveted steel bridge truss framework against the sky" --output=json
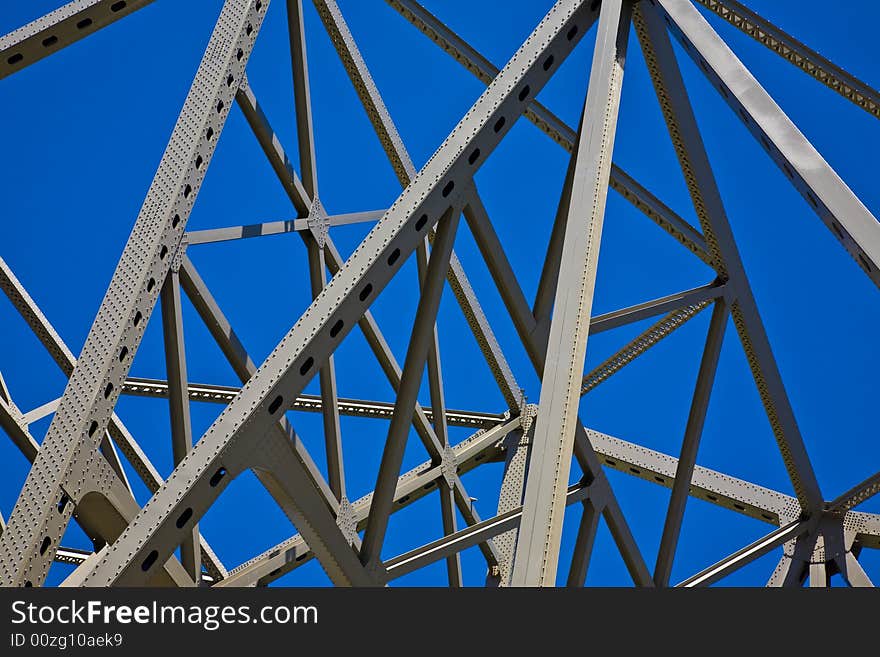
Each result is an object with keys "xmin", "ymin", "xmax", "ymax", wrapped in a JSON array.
[{"xmin": 0, "ymin": 0, "xmax": 880, "ymax": 586}]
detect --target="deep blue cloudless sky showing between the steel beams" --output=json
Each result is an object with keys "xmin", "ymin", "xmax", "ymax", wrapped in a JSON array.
[{"xmin": 0, "ymin": 0, "xmax": 880, "ymax": 585}]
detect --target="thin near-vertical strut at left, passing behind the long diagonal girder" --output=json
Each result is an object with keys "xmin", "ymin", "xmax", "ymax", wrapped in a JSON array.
[{"xmin": 160, "ymin": 265, "xmax": 202, "ymax": 584}]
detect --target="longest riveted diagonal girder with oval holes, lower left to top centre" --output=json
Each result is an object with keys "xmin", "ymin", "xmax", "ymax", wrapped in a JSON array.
[{"xmin": 53, "ymin": 0, "xmax": 624, "ymax": 586}]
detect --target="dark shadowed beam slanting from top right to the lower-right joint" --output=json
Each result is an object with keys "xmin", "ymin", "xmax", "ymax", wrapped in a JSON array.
[{"xmin": 635, "ymin": 0, "xmax": 824, "ymax": 512}]
